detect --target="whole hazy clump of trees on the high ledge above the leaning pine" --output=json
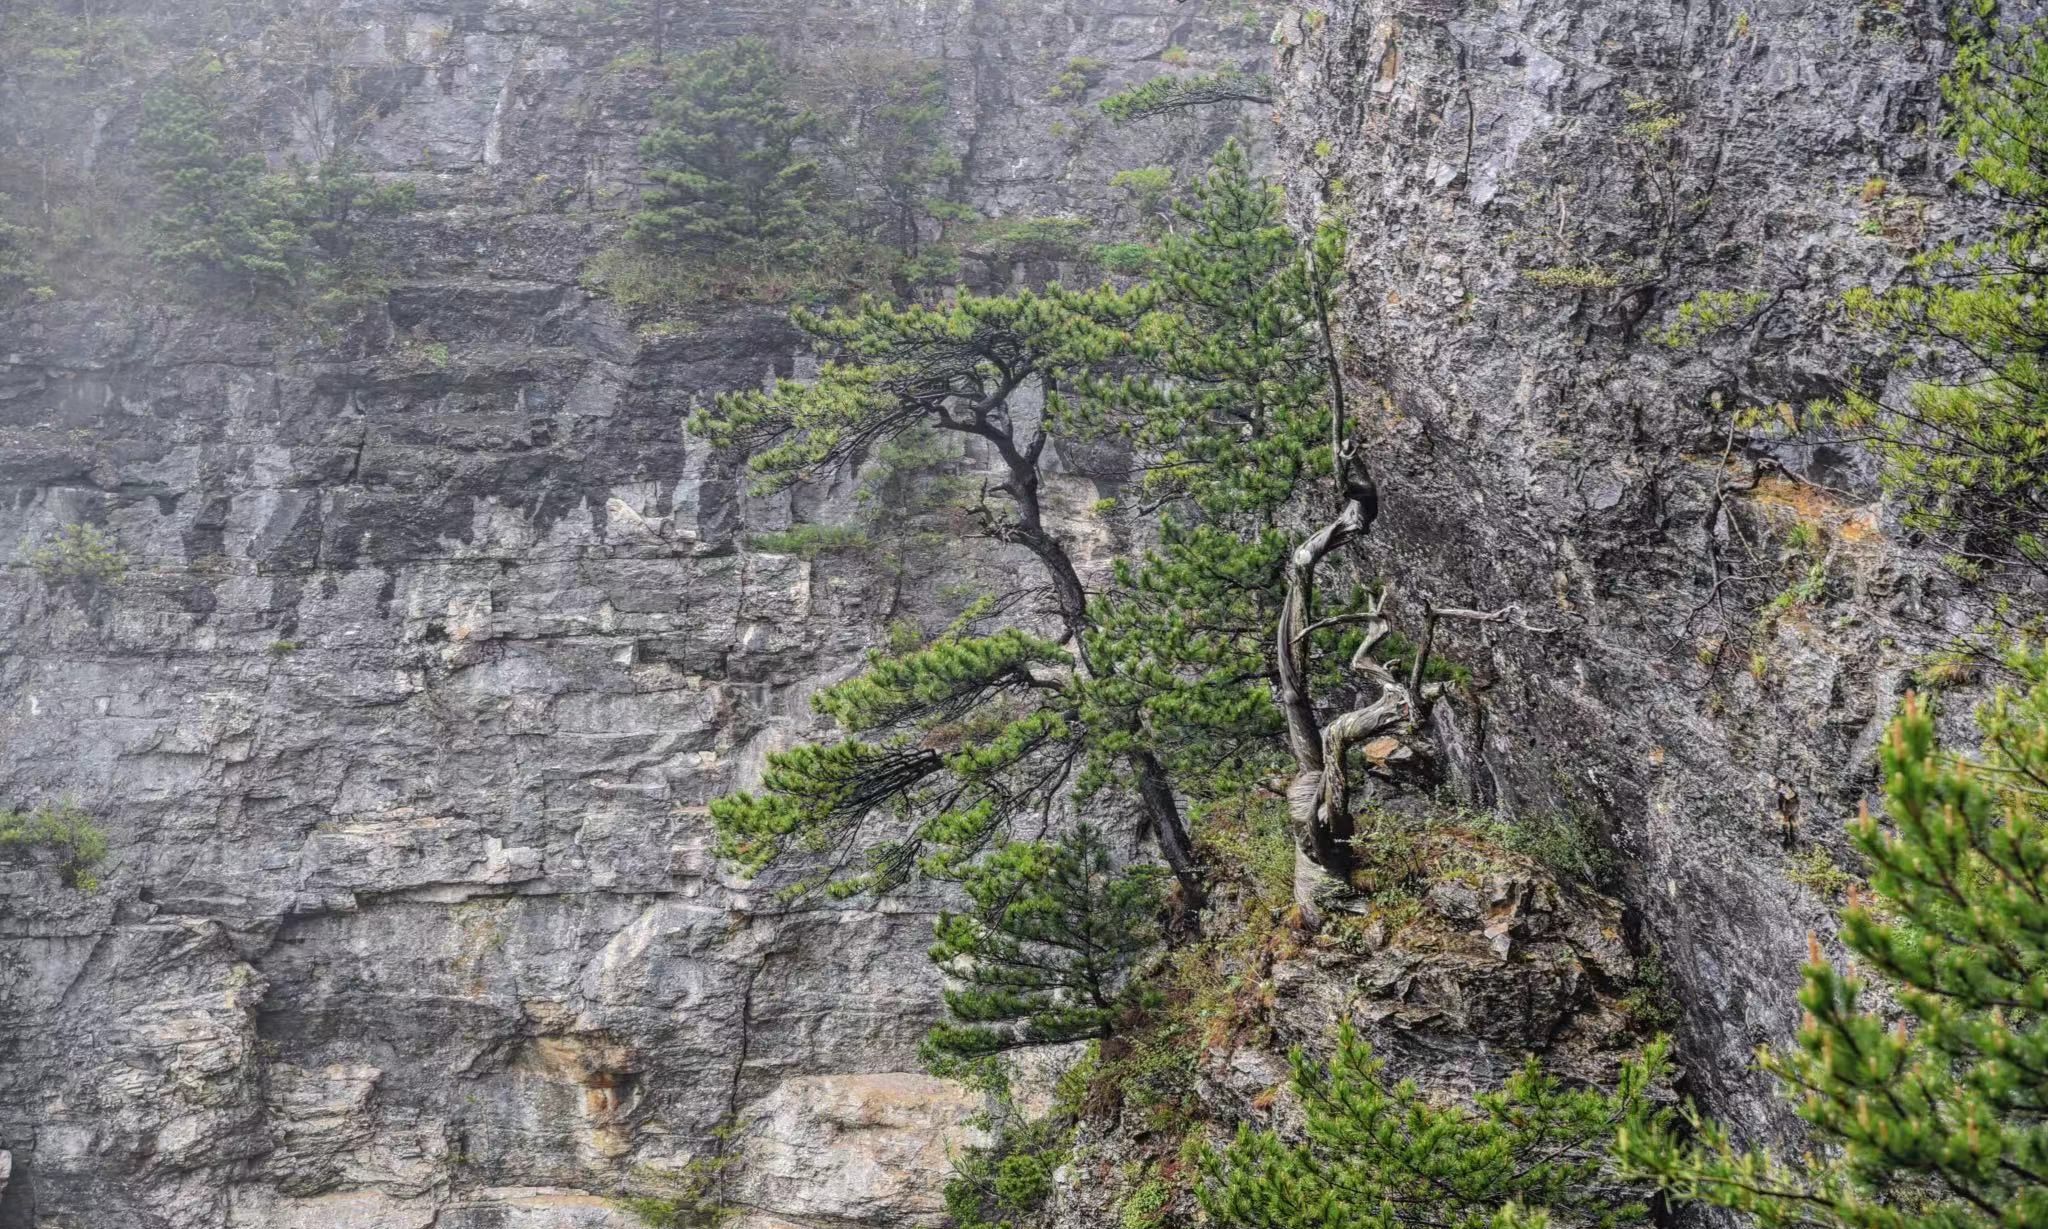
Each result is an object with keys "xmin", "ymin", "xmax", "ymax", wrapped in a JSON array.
[{"xmin": 602, "ymin": 39, "xmax": 973, "ymax": 313}]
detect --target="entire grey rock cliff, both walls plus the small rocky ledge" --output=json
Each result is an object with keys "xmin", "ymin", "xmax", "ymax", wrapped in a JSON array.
[{"xmin": 0, "ymin": 0, "xmax": 1982, "ymax": 1229}]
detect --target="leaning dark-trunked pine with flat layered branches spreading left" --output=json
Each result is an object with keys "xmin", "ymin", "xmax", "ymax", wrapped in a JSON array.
[{"xmin": 692, "ymin": 287, "xmax": 1200, "ymax": 897}]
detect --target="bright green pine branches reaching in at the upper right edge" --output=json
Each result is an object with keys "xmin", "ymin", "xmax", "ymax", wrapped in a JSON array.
[{"xmin": 1821, "ymin": 13, "xmax": 2048, "ymax": 576}]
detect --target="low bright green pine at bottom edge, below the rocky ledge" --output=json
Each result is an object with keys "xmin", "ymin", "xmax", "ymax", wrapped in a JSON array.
[{"xmin": 1200, "ymin": 1024, "xmax": 1663, "ymax": 1229}]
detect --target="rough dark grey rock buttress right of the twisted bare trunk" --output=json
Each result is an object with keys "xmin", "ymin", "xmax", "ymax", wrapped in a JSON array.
[{"xmin": 1276, "ymin": 0, "xmax": 1950, "ymax": 1131}]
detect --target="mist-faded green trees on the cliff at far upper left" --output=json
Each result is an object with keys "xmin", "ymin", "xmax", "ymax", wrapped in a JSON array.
[{"xmin": 137, "ymin": 61, "xmax": 414, "ymax": 315}]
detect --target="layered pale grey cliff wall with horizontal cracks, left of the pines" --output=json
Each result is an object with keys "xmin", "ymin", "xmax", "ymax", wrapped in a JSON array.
[{"xmin": 0, "ymin": 0, "xmax": 1266, "ymax": 1229}]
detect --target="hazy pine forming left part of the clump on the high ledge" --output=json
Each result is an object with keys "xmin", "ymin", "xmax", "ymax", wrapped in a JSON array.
[{"xmin": 627, "ymin": 39, "xmax": 819, "ymax": 268}]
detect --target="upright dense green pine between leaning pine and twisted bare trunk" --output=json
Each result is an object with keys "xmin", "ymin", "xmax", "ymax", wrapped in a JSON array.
[{"xmin": 1057, "ymin": 141, "xmax": 1341, "ymax": 793}]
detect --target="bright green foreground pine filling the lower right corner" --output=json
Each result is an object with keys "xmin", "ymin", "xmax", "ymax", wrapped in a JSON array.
[{"xmin": 1618, "ymin": 649, "xmax": 2048, "ymax": 1229}]
